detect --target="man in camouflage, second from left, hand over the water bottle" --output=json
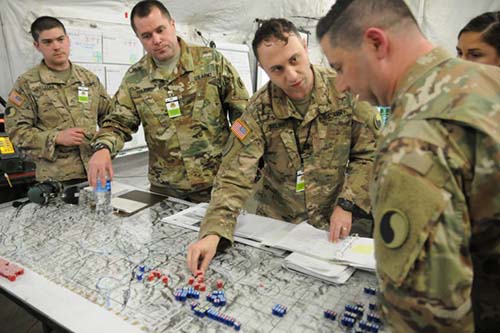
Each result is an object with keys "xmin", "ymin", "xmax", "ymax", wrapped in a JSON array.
[{"xmin": 89, "ymin": 1, "xmax": 248, "ymax": 202}]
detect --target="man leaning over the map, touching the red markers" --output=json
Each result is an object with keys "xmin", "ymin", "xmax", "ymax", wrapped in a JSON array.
[{"xmin": 188, "ymin": 19, "xmax": 380, "ymax": 272}]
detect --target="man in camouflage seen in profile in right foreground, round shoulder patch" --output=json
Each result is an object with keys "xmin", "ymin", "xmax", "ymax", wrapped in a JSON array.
[{"xmin": 317, "ymin": 0, "xmax": 500, "ymax": 333}]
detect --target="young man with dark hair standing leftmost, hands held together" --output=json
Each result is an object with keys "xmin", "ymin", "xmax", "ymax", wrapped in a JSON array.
[{"xmin": 5, "ymin": 16, "xmax": 111, "ymax": 182}]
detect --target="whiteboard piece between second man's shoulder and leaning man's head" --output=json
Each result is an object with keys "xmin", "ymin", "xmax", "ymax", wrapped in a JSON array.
[{"xmin": 216, "ymin": 43, "xmax": 253, "ymax": 96}]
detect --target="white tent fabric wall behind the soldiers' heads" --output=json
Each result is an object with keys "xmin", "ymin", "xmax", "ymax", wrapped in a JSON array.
[{"xmin": 0, "ymin": 0, "xmax": 500, "ymax": 98}]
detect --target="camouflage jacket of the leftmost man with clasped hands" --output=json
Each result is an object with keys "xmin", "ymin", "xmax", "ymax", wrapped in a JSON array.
[{"xmin": 5, "ymin": 61, "xmax": 111, "ymax": 181}]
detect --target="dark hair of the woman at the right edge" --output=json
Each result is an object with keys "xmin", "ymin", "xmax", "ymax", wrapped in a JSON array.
[{"xmin": 458, "ymin": 11, "xmax": 500, "ymax": 55}]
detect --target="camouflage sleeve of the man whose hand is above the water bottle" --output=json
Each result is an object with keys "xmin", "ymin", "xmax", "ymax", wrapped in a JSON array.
[{"xmin": 94, "ymin": 77, "xmax": 141, "ymax": 156}]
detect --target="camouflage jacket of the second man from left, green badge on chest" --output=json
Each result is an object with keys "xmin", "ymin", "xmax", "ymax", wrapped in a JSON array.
[{"xmin": 96, "ymin": 38, "xmax": 248, "ymax": 196}]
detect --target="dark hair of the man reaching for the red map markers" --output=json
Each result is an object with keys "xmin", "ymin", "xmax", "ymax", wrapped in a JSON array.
[{"xmin": 252, "ymin": 18, "xmax": 300, "ymax": 60}]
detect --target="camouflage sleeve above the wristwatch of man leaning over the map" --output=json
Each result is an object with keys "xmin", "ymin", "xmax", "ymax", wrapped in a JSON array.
[{"xmin": 339, "ymin": 98, "xmax": 382, "ymax": 213}]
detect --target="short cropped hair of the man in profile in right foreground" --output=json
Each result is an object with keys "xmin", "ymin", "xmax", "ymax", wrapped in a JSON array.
[{"xmin": 316, "ymin": 0, "xmax": 418, "ymax": 48}]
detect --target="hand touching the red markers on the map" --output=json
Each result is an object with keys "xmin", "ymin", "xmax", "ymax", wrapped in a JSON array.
[{"xmin": 187, "ymin": 235, "xmax": 220, "ymax": 274}]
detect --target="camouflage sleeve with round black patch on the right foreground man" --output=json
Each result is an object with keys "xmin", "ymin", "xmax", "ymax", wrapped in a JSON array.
[{"xmin": 372, "ymin": 116, "xmax": 500, "ymax": 332}]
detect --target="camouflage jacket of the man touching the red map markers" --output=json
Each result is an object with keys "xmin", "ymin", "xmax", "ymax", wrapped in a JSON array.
[{"xmin": 200, "ymin": 66, "xmax": 379, "ymax": 240}]
